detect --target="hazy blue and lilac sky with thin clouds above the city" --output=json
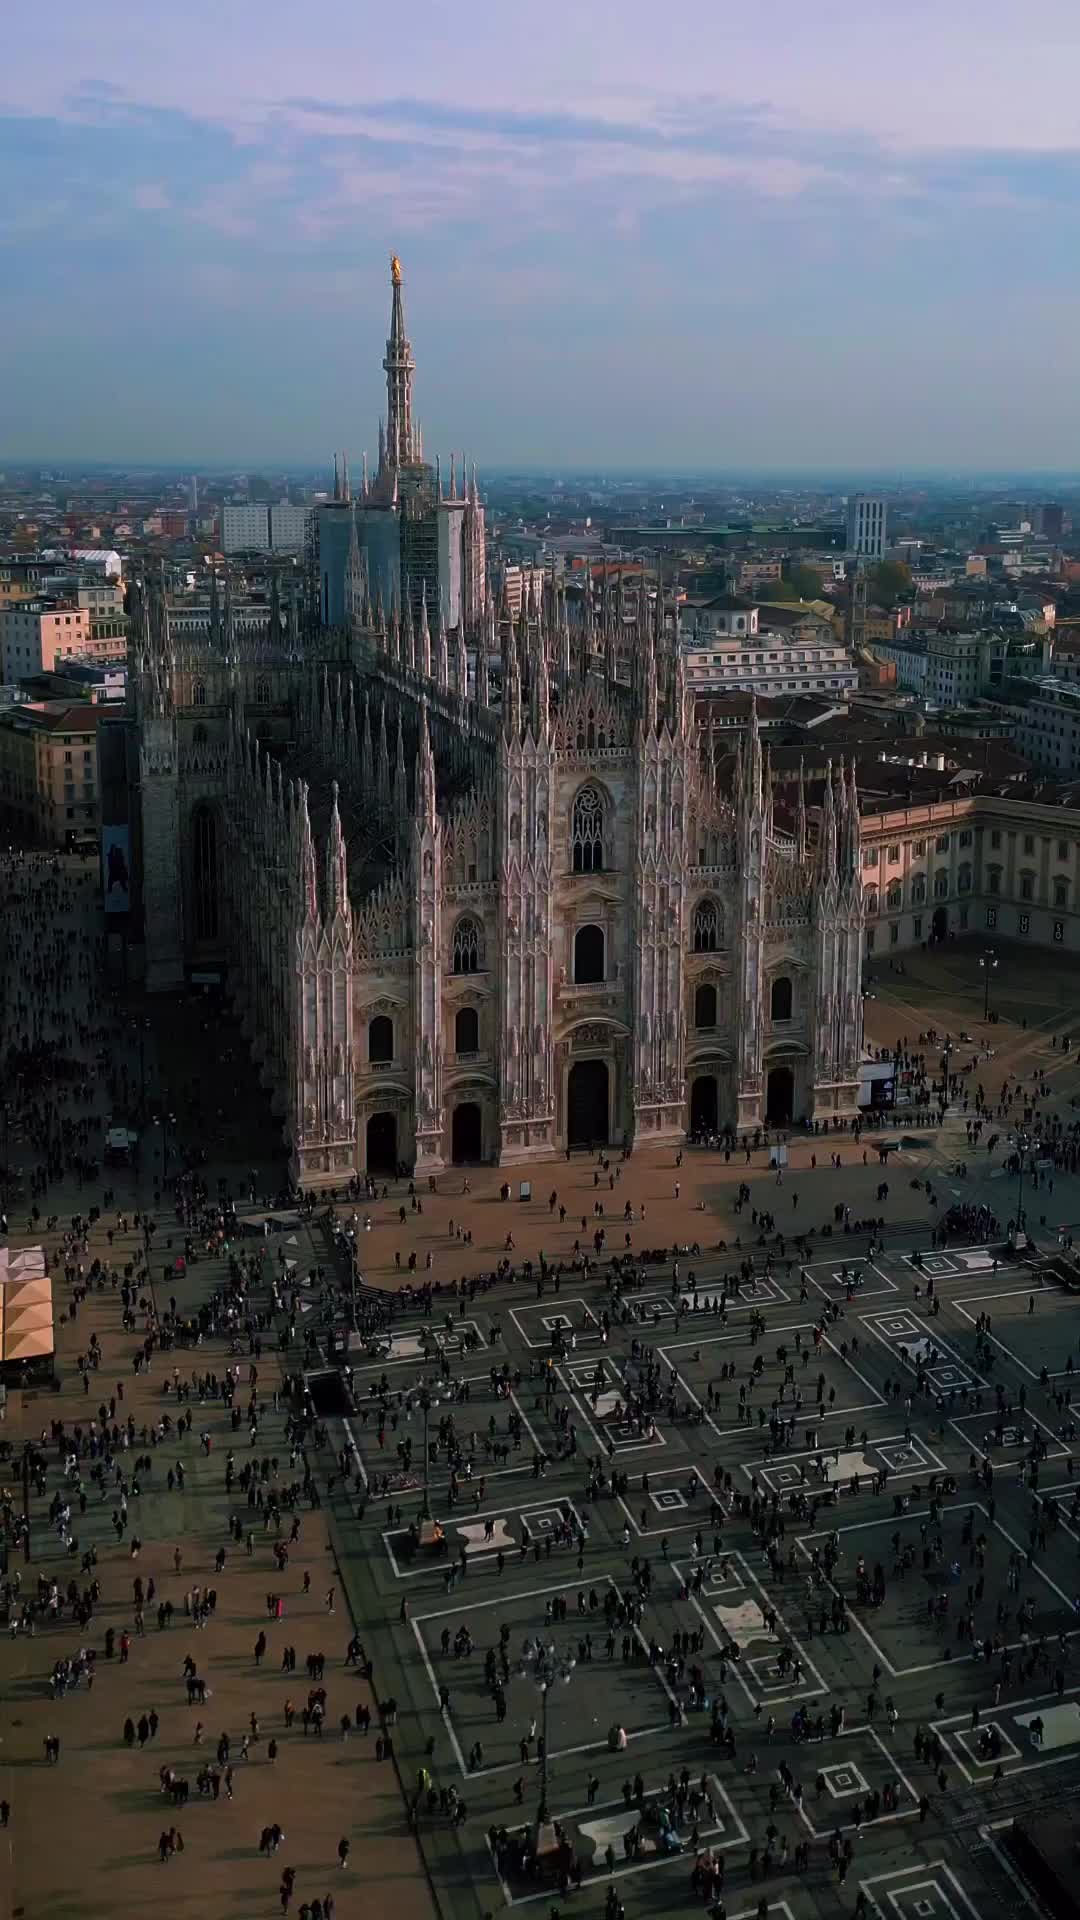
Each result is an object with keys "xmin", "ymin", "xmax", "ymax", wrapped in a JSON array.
[{"xmin": 0, "ymin": 0, "xmax": 1080, "ymax": 472}]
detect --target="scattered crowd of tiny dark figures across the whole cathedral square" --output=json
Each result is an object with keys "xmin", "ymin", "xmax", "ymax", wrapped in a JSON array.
[{"xmin": 0, "ymin": 856, "xmax": 1080, "ymax": 1920}]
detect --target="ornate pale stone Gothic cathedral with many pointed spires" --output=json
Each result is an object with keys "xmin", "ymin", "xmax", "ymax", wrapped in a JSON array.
[{"xmin": 131, "ymin": 255, "xmax": 863, "ymax": 1188}]
